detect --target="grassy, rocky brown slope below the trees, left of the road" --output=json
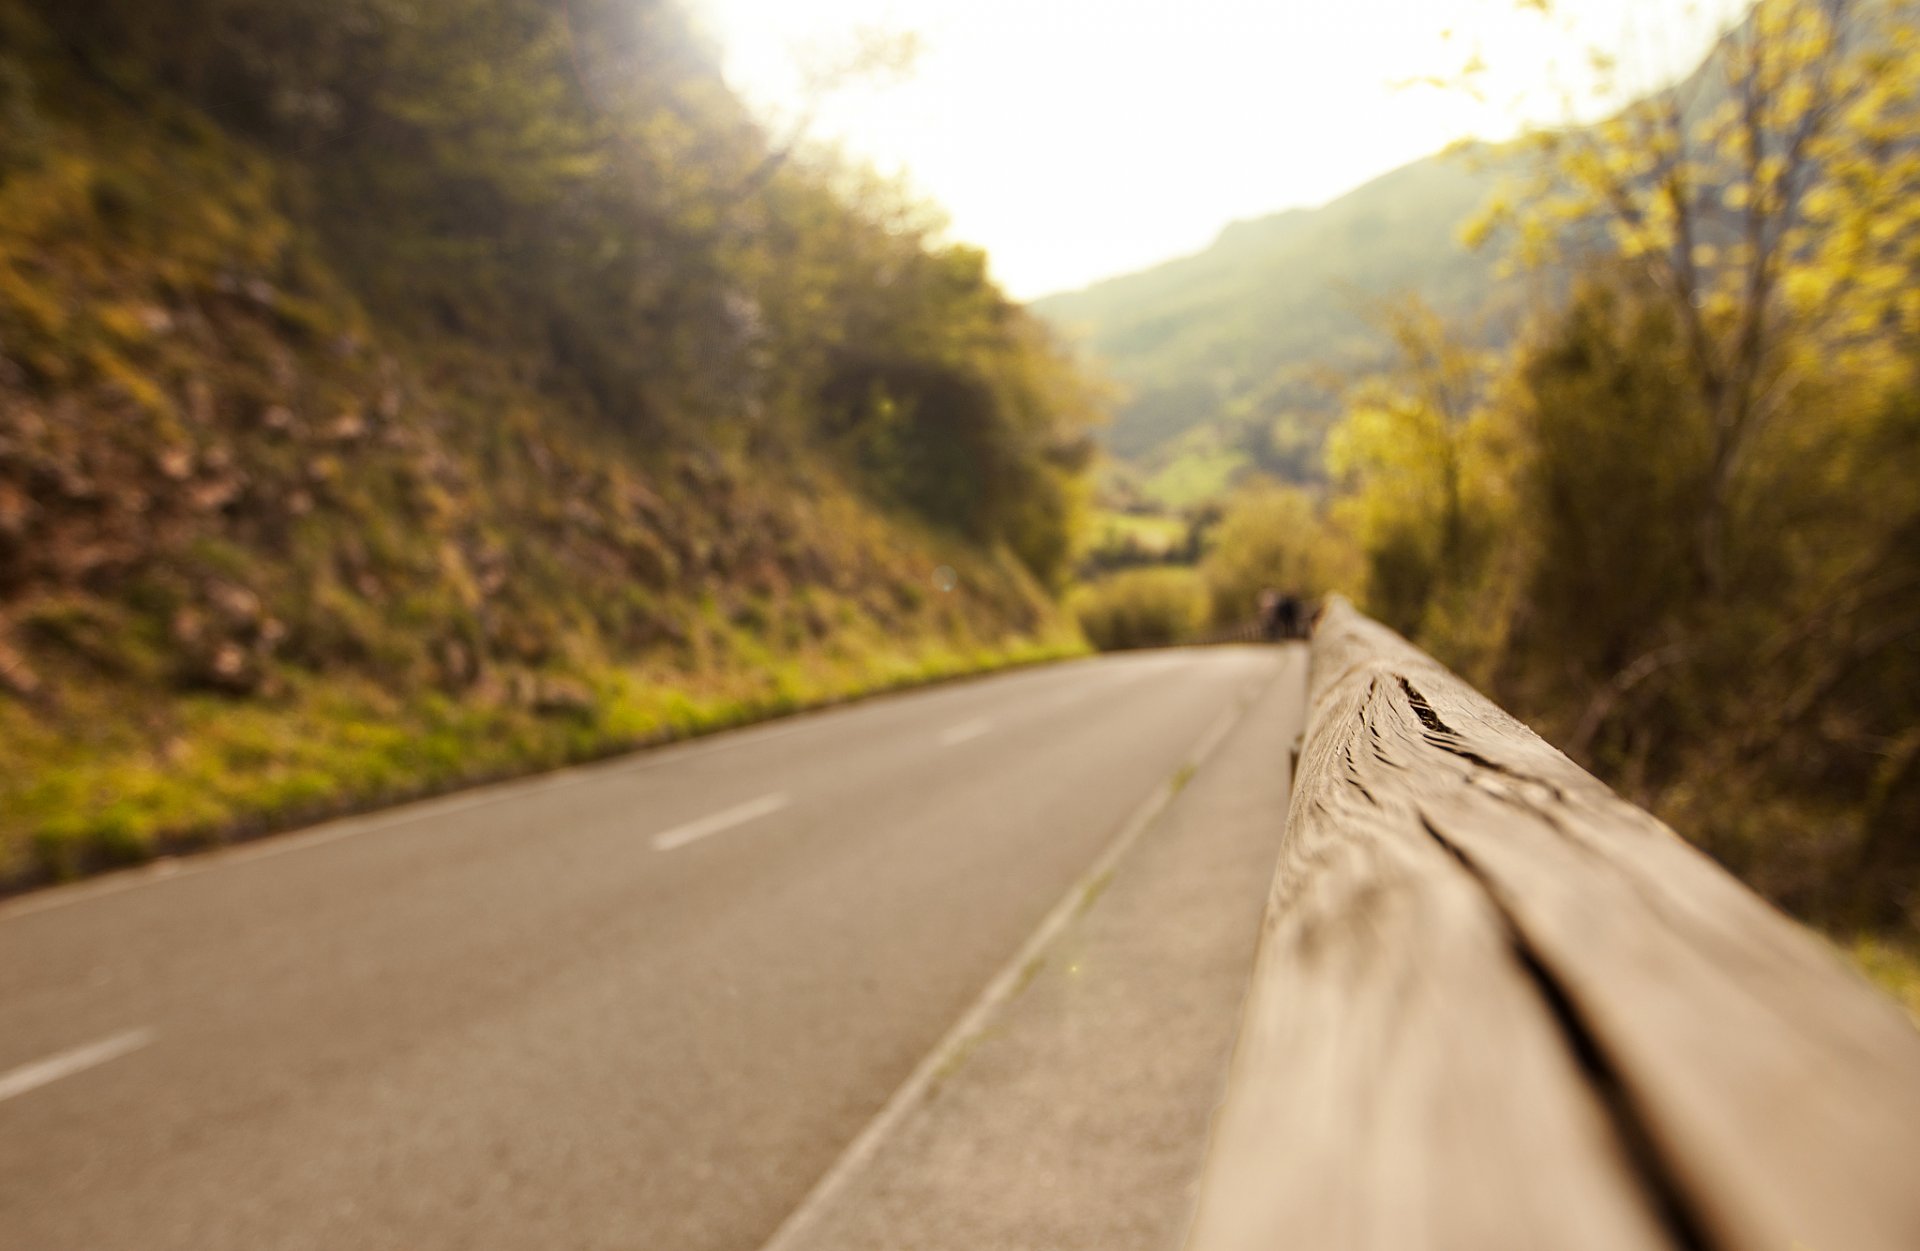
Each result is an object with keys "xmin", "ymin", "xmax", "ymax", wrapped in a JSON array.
[{"xmin": 0, "ymin": 29, "xmax": 1081, "ymax": 886}]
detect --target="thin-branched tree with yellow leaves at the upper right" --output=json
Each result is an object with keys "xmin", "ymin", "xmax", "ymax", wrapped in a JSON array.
[{"xmin": 1471, "ymin": 0, "xmax": 1920, "ymax": 593}]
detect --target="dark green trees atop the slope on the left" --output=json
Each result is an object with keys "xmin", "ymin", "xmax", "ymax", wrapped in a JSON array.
[{"xmin": 8, "ymin": 0, "xmax": 1098, "ymax": 583}]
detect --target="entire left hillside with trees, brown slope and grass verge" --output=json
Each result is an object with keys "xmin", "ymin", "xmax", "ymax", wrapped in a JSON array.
[{"xmin": 0, "ymin": 0, "xmax": 1098, "ymax": 885}]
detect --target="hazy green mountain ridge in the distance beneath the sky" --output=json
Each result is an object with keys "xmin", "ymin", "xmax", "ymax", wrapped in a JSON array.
[{"xmin": 1033, "ymin": 150, "xmax": 1503, "ymax": 505}]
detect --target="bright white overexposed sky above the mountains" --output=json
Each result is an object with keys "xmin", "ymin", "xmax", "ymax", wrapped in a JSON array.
[{"xmin": 691, "ymin": 0, "xmax": 1743, "ymax": 299}]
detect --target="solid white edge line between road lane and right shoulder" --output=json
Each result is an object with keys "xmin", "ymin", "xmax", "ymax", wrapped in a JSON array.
[{"xmin": 760, "ymin": 685, "xmax": 1265, "ymax": 1251}]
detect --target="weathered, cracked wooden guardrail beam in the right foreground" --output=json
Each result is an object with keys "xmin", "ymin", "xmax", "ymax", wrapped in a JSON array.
[{"xmin": 1188, "ymin": 599, "xmax": 1920, "ymax": 1251}]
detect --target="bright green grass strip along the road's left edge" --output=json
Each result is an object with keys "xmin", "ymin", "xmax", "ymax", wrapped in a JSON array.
[{"xmin": 0, "ymin": 633, "xmax": 1085, "ymax": 886}]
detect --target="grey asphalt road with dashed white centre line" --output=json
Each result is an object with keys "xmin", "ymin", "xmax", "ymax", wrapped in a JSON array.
[{"xmin": 0, "ymin": 649, "xmax": 1283, "ymax": 1251}]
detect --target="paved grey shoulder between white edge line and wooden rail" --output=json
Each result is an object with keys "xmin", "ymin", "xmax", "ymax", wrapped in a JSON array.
[{"xmin": 776, "ymin": 649, "xmax": 1306, "ymax": 1251}]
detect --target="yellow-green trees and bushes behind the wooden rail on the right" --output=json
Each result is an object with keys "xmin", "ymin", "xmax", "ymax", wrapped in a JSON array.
[{"xmin": 1113, "ymin": 0, "xmax": 1920, "ymax": 967}]
